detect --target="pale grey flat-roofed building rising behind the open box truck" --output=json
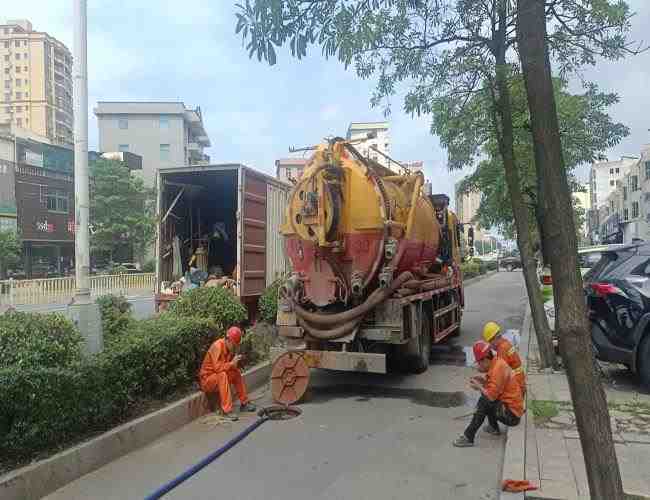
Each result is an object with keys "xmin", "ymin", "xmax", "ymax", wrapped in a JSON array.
[{"xmin": 95, "ymin": 101, "xmax": 210, "ymax": 187}]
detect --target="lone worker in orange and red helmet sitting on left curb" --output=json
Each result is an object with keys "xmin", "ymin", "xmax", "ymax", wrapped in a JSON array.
[{"xmin": 199, "ymin": 326, "xmax": 256, "ymax": 421}]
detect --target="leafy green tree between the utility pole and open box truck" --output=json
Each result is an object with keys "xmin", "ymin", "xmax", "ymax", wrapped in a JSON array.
[{"xmin": 90, "ymin": 159, "xmax": 154, "ymax": 260}]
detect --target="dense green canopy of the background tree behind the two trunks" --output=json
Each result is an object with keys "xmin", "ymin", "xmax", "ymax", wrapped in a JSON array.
[{"xmin": 454, "ymin": 78, "xmax": 629, "ymax": 235}]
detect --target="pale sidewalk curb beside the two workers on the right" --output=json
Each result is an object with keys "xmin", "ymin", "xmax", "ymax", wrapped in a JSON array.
[{"xmin": 499, "ymin": 305, "xmax": 532, "ymax": 500}]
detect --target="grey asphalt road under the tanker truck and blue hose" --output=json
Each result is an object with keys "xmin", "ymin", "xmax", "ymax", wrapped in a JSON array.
[{"xmin": 47, "ymin": 272, "xmax": 524, "ymax": 500}]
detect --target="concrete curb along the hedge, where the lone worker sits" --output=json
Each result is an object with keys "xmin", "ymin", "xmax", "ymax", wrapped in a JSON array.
[{"xmin": 0, "ymin": 361, "xmax": 271, "ymax": 500}]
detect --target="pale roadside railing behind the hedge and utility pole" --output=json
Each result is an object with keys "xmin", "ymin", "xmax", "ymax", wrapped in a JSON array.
[{"xmin": 0, "ymin": 273, "xmax": 156, "ymax": 306}]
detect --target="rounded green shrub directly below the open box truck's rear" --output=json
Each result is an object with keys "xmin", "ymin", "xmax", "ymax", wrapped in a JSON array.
[{"xmin": 169, "ymin": 287, "xmax": 248, "ymax": 330}]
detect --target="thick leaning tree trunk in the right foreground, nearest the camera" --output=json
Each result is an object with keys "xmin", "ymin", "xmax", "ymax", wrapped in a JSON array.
[{"xmin": 518, "ymin": 0, "xmax": 624, "ymax": 500}]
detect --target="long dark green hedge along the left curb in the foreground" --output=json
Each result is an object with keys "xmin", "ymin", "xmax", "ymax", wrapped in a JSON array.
[{"xmin": 0, "ymin": 314, "xmax": 218, "ymax": 459}]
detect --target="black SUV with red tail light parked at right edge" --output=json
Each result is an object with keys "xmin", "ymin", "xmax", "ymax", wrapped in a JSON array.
[{"xmin": 584, "ymin": 243, "xmax": 650, "ymax": 390}]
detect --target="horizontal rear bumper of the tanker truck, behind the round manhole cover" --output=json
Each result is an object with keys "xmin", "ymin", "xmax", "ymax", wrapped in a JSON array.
[{"xmin": 271, "ymin": 347, "xmax": 386, "ymax": 373}]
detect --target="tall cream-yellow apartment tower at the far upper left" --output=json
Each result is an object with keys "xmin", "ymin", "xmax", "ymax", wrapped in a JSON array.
[{"xmin": 0, "ymin": 19, "xmax": 73, "ymax": 145}]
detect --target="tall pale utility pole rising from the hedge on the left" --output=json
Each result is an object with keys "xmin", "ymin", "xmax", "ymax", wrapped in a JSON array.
[{"xmin": 69, "ymin": 0, "xmax": 103, "ymax": 354}]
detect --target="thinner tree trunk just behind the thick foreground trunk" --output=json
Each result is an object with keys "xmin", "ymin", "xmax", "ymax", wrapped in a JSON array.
[{"xmin": 492, "ymin": 0, "xmax": 557, "ymax": 368}]
